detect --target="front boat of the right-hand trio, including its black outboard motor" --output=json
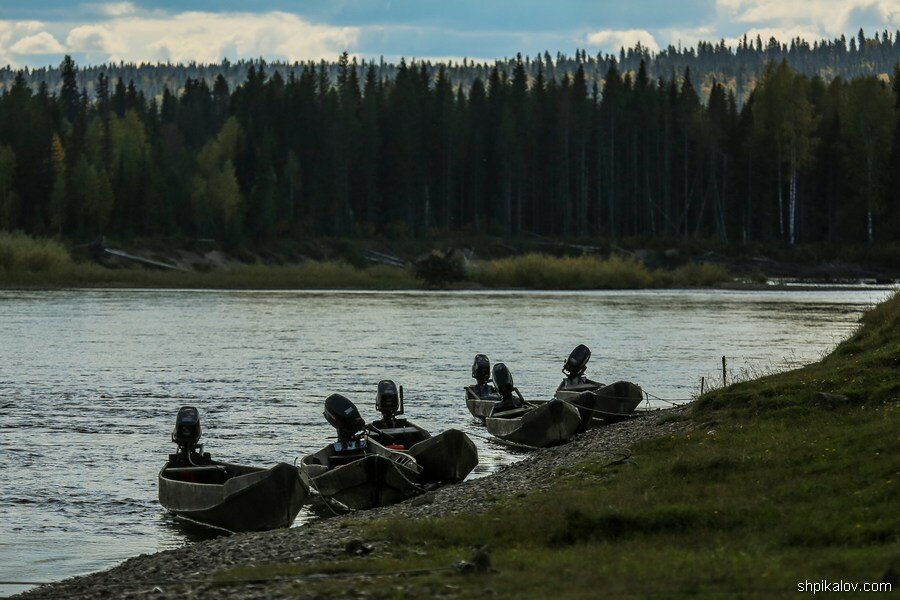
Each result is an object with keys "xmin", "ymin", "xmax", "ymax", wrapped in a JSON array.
[{"xmin": 485, "ymin": 363, "xmax": 581, "ymax": 448}]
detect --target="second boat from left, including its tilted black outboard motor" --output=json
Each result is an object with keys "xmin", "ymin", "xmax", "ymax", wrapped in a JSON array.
[{"xmin": 300, "ymin": 394, "xmax": 422, "ymax": 510}]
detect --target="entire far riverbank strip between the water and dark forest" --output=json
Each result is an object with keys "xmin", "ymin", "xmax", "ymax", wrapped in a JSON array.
[{"xmin": 0, "ymin": 233, "xmax": 900, "ymax": 290}]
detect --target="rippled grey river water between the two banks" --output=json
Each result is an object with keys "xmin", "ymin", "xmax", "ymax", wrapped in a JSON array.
[{"xmin": 0, "ymin": 288, "xmax": 889, "ymax": 595}]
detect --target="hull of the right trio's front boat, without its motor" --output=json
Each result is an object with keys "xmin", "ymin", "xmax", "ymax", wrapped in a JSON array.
[{"xmin": 485, "ymin": 401, "xmax": 581, "ymax": 448}]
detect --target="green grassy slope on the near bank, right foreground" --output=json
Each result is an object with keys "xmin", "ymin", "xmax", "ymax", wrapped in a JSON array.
[{"xmin": 216, "ymin": 296, "xmax": 900, "ymax": 598}]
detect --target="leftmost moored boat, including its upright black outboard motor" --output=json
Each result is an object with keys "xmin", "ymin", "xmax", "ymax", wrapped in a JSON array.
[{"xmin": 158, "ymin": 406, "xmax": 309, "ymax": 532}]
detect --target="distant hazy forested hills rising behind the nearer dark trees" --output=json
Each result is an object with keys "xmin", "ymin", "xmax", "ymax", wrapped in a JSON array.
[{"xmin": 0, "ymin": 29, "xmax": 900, "ymax": 108}]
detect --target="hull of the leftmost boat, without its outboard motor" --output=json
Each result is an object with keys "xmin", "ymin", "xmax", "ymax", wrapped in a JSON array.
[{"xmin": 158, "ymin": 463, "xmax": 309, "ymax": 532}]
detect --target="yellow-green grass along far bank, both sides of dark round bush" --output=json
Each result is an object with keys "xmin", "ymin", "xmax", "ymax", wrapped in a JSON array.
[{"xmin": 0, "ymin": 233, "xmax": 733, "ymax": 289}]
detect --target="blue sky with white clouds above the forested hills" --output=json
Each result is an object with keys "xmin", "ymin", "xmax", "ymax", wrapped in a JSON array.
[{"xmin": 0, "ymin": 0, "xmax": 900, "ymax": 67}]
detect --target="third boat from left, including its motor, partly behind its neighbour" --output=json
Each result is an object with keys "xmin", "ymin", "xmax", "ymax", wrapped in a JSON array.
[{"xmin": 367, "ymin": 380, "xmax": 478, "ymax": 483}]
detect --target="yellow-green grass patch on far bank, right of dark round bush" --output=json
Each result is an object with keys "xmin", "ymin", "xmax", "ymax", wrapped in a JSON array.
[{"xmin": 469, "ymin": 254, "xmax": 733, "ymax": 290}]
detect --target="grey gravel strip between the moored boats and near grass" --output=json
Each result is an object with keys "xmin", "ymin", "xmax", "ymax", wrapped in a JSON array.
[{"xmin": 14, "ymin": 407, "xmax": 689, "ymax": 599}]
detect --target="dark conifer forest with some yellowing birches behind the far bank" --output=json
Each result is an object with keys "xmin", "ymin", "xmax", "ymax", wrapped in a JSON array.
[{"xmin": 0, "ymin": 44, "xmax": 900, "ymax": 245}]
